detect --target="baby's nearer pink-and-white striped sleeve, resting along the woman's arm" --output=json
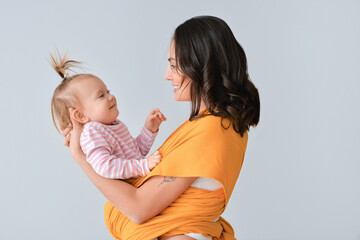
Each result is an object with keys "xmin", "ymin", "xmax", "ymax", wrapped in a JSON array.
[{"xmin": 80, "ymin": 124, "xmax": 150, "ymax": 179}]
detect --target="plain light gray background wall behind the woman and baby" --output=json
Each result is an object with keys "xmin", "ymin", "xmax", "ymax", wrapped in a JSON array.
[{"xmin": 0, "ymin": 0, "xmax": 360, "ymax": 240}]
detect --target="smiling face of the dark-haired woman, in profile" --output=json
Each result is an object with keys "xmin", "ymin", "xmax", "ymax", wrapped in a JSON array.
[{"xmin": 165, "ymin": 42, "xmax": 191, "ymax": 101}]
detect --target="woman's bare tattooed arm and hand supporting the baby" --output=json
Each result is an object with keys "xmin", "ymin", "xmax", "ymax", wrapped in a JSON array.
[{"xmin": 64, "ymin": 110, "xmax": 196, "ymax": 224}]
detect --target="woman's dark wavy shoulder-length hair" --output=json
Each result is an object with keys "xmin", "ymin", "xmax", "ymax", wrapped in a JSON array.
[{"xmin": 173, "ymin": 16, "xmax": 260, "ymax": 136}]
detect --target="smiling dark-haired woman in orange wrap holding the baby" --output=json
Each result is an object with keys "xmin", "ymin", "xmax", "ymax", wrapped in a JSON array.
[{"xmin": 63, "ymin": 16, "xmax": 260, "ymax": 239}]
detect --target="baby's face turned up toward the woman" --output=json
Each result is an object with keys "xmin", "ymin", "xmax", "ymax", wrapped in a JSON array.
[{"xmin": 72, "ymin": 77, "xmax": 119, "ymax": 125}]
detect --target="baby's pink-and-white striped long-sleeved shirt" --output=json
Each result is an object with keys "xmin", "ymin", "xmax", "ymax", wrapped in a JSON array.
[{"xmin": 80, "ymin": 120, "xmax": 157, "ymax": 179}]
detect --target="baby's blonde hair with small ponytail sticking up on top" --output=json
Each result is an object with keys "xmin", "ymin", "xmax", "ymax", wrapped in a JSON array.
[{"xmin": 49, "ymin": 50, "xmax": 97, "ymax": 132}]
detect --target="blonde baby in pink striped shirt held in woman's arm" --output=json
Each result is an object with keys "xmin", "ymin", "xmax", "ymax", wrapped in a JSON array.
[{"xmin": 50, "ymin": 53, "xmax": 166, "ymax": 179}]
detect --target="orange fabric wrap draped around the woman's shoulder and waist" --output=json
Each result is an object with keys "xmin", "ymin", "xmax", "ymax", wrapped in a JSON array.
[{"xmin": 105, "ymin": 115, "xmax": 248, "ymax": 240}]
